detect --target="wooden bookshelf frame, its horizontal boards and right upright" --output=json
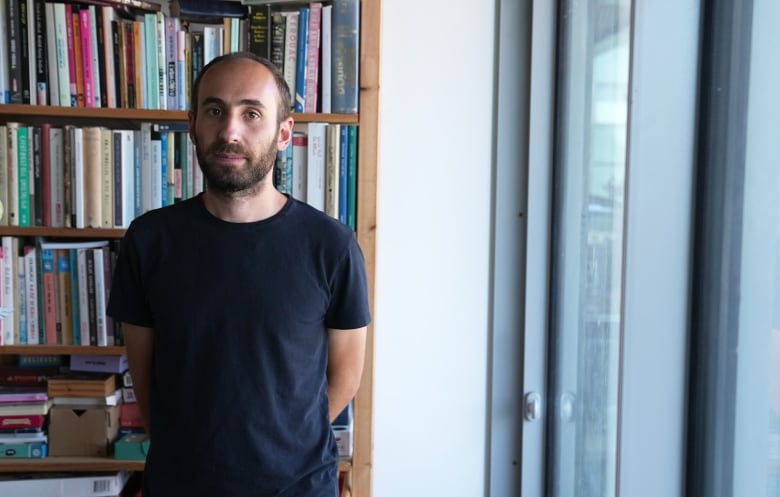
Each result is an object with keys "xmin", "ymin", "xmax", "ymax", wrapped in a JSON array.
[{"xmin": 0, "ymin": 0, "xmax": 381, "ymax": 497}]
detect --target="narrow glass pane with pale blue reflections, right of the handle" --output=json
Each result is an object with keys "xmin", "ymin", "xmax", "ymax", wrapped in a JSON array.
[{"xmin": 548, "ymin": 0, "xmax": 631, "ymax": 497}]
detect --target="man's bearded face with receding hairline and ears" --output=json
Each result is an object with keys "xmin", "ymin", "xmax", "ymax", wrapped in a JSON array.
[{"xmin": 190, "ymin": 59, "xmax": 287, "ymax": 194}]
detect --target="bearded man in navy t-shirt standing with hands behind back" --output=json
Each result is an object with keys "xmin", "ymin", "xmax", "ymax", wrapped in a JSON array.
[{"xmin": 108, "ymin": 53, "xmax": 370, "ymax": 497}]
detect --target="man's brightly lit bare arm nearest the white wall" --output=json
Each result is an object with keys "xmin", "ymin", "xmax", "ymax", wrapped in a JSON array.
[{"xmin": 328, "ymin": 327, "xmax": 366, "ymax": 422}]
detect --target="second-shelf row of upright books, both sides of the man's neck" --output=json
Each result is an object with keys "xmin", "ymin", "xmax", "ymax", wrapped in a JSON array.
[{"xmin": 0, "ymin": 122, "xmax": 358, "ymax": 230}]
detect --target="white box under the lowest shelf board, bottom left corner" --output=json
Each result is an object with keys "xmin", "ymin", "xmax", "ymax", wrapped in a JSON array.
[{"xmin": 0, "ymin": 471, "xmax": 130, "ymax": 497}]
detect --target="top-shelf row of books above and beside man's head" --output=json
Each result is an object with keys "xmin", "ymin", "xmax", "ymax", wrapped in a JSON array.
[{"xmin": 0, "ymin": 0, "xmax": 359, "ymax": 113}]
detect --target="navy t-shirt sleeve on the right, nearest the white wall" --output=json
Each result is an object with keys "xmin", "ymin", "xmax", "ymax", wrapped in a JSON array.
[{"xmin": 325, "ymin": 237, "xmax": 371, "ymax": 330}]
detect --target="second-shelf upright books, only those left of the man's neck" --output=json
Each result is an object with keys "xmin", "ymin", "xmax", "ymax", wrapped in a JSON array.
[{"xmin": 0, "ymin": 122, "xmax": 204, "ymax": 228}]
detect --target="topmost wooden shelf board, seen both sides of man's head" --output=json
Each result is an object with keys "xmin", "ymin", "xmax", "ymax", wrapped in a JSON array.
[{"xmin": 0, "ymin": 104, "xmax": 359, "ymax": 124}]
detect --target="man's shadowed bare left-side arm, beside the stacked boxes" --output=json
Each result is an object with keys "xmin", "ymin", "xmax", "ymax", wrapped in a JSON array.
[{"xmin": 122, "ymin": 323, "xmax": 154, "ymax": 438}]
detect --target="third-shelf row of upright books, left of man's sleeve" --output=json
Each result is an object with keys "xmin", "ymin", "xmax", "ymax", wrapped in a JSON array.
[{"xmin": 0, "ymin": 236, "xmax": 123, "ymax": 346}]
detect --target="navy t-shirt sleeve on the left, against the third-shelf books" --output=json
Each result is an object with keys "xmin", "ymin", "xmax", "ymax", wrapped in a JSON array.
[{"xmin": 106, "ymin": 226, "xmax": 154, "ymax": 328}]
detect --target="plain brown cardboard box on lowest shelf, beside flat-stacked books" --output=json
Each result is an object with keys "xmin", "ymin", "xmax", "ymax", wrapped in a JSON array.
[{"xmin": 49, "ymin": 405, "xmax": 119, "ymax": 457}]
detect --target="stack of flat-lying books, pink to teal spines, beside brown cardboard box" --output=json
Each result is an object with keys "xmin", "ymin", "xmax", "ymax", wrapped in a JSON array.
[{"xmin": 0, "ymin": 386, "xmax": 51, "ymax": 458}]
